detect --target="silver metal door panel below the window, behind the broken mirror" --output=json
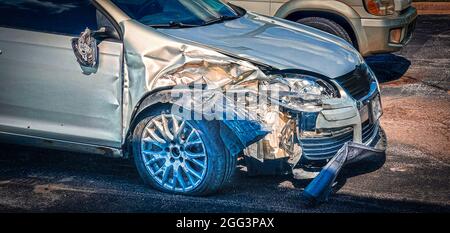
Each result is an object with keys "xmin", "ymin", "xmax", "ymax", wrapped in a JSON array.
[{"xmin": 0, "ymin": 28, "xmax": 122, "ymax": 147}]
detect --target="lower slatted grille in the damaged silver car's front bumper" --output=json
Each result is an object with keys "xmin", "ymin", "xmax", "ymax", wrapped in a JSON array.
[{"xmin": 301, "ymin": 121, "xmax": 380, "ymax": 160}]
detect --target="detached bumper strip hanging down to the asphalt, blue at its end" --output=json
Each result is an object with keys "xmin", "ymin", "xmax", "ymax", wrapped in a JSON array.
[{"xmin": 303, "ymin": 142, "xmax": 385, "ymax": 205}]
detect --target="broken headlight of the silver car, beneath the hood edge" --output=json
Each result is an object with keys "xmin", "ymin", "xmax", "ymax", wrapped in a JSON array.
[{"xmin": 268, "ymin": 74, "xmax": 339, "ymax": 111}]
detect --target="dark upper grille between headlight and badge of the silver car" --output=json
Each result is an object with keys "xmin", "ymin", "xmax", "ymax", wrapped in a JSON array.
[{"xmin": 336, "ymin": 64, "xmax": 372, "ymax": 100}]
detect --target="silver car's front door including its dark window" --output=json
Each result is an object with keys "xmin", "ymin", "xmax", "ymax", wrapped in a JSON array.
[{"xmin": 0, "ymin": 0, "xmax": 123, "ymax": 147}]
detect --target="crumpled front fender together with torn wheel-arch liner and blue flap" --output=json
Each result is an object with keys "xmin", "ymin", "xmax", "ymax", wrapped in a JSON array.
[{"xmin": 121, "ymin": 20, "xmax": 308, "ymax": 159}]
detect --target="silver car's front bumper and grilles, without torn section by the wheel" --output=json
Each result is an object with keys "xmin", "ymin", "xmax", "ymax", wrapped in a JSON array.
[{"xmin": 297, "ymin": 63, "xmax": 386, "ymax": 167}]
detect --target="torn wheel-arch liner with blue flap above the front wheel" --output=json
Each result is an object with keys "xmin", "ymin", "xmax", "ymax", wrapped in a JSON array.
[{"xmin": 125, "ymin": 87, "xmax": 270, "ymax": 156}]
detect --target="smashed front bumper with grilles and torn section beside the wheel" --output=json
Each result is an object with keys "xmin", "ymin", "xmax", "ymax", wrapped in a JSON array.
[{"xmin": 244, "ymin": 65, "xmax": 386, "ymax": 175}]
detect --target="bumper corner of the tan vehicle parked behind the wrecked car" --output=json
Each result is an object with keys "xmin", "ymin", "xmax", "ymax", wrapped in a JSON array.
[{"xmin": 358, "ymin": 7, "xmax": 417, "ymax": 56}]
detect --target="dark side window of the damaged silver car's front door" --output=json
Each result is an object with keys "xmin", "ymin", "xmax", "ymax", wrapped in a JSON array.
[{"xmin": 0, "ymin": 0, "xmax": 97, "ymax": 35}]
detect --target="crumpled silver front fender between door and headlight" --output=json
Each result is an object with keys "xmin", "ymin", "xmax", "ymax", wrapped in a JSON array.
[{"xmin": 120, "ymin": 20, "xmax": 265, "ymax": 141}]
